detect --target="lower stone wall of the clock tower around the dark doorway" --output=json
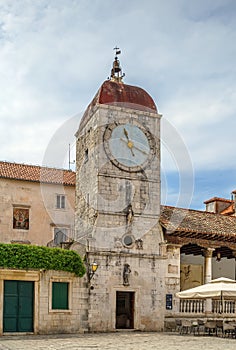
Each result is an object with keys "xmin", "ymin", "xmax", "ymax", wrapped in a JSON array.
[{"xmin": 88, "ymin": 252, "xmax": 166, "ymax": 332}]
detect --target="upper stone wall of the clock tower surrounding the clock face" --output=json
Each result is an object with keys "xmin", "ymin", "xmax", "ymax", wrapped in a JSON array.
[{"xmin": 75, "ymin": 105, "xmax": 162, "ymax": 253}]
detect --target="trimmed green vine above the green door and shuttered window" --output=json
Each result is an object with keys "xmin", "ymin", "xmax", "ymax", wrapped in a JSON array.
[{"xmin": 0, "ymin": 243, "xmax": 86, "ymax": 277}]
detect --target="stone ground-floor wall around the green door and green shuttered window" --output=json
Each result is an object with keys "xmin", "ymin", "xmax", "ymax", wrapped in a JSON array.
[{"xmin": 0, "ymin": 269, "xmax": 88, "ymax": 335}]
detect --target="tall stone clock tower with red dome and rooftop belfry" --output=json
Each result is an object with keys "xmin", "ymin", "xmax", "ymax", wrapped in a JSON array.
[{"xmin": 75, "ymin": 49, "xmax": 165, "ymax": 331}]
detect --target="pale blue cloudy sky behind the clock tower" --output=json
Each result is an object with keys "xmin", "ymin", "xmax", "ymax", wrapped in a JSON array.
[{"xmin": 0, "ymin": 0, "xmax": 236, "ymax": 209}]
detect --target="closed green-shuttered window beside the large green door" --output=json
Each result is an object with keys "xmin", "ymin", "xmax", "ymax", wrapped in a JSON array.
[{"xmin": 52, "ymin": 282, "xmax": 69, "ymax": 310}]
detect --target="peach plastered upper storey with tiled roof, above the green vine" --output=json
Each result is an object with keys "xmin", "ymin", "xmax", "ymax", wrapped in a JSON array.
[{"xmin": 0, "ymin": 162, "xmax": 75, "ymax": 246}]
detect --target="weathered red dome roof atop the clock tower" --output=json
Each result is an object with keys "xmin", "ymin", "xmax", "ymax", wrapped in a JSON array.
[{"xmin": 79, "ymin": 80, "xmax": 157, "ymax": 130}]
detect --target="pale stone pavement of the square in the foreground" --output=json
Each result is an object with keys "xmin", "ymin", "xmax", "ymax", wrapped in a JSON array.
[{"xmin": 0, "ymin": 332, "xmax": 236, "ymax": 350}]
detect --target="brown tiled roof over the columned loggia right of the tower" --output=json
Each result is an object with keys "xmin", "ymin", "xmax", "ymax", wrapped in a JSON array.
[{"xmin": 160, "ymin": 206, "xmax": 236, "ymax": 238}]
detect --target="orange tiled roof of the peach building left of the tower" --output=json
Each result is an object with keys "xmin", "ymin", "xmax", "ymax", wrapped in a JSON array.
[{"xmin": 0, "ymin": 162, "xmax": 75, "ymax": 186}]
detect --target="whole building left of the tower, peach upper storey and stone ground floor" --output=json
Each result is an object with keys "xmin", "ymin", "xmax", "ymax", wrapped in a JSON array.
[{"xmin": 0, "ymin": 162, "xmax": 88, "ymax": 335}]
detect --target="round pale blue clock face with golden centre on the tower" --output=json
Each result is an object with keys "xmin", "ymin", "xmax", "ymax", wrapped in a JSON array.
[{"xmin": 104, "ymin": 123, "xmax": 154, "ymax": 171}]
